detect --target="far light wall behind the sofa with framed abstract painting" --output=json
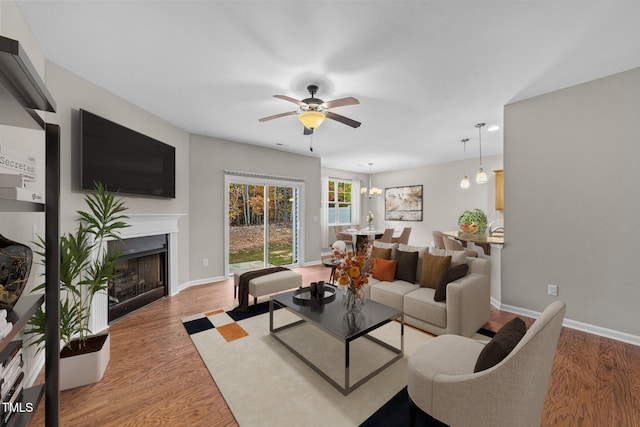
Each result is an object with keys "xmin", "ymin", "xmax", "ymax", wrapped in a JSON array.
[{"xmin": 370, "ymin": 156, "xmax": 506, "ymax": 246}]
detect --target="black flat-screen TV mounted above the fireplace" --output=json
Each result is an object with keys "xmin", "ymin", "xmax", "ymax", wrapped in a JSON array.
[{"xmin": 80, "ymin": 110, "xmax": 176, "ymax": 198}]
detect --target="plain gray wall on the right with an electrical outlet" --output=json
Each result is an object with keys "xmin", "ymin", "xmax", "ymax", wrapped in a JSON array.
[{"xmin": 502, "ymin": 69, "xmax": 640, "ymax": 336}]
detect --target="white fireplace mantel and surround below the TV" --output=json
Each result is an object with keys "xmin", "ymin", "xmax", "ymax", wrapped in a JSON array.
[{"xmin": 90, "ymin": 214, "xmax": 186, "ymax": 333}]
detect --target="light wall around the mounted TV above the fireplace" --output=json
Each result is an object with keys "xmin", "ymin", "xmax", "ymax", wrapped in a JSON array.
[{"xmin": 46, "ymin": 62, "xmax": 189, "ymax": 290}]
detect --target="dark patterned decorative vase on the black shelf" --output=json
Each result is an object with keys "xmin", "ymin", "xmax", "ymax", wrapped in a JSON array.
[{"xmin": 0, "ymin": 235, "xmax": 33, "ymax": 310}]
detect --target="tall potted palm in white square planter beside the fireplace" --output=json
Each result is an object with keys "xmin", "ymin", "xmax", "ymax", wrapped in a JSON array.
[{"xmin": 24, "ymin": 182, "xmax": 128, "ymax": 390}]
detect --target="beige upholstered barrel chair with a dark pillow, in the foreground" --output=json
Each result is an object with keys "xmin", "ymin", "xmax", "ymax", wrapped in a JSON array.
[{"xmin": 407, "ymin": 301, "xmax": 566, "ymax": 427}]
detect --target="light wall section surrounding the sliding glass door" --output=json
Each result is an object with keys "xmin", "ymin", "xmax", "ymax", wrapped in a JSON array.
[{"xmin": 189, "ymin": 135, "xmax": 321, "ymax": 283}]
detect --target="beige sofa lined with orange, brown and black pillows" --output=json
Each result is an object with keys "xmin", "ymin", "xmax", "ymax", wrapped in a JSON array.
[{"xmin": 365, "ymin": 241, "xmax": 490, "ymax": 337}]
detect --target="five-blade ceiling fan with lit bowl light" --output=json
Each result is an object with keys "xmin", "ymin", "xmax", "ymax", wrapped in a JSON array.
[{"xmin": 258, "ymin": 85, "xmax": 360, "ymax": 135}]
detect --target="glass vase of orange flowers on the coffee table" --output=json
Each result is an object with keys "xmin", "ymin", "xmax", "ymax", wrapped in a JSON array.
[{"xmin": 333, "ymin": 247, "xmax": 369, "ymax": 313}]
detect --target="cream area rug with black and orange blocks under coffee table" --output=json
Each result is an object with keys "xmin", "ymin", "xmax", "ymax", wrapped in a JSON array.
[{"xmin": 182, "ymin": 303, "xmax": 433, "ymax": 427}]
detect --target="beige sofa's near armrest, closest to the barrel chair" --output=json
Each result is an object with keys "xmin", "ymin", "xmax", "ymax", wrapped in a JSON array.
[{"xmin": 446, "ymin": 273, "xmax": 491, "ymax": 337}]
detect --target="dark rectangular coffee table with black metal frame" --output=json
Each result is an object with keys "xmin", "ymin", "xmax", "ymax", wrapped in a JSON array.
[{"xmin": 269, "ymin": 291, "xmax": 404, "ymax": 395}]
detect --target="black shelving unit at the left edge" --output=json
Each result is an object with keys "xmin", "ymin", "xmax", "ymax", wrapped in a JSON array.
[{"xmin": 0, "ymin": 36, "xmax": 60, "ymax": 426}]
